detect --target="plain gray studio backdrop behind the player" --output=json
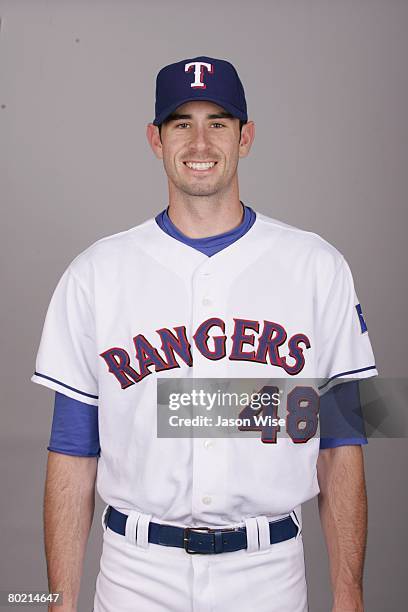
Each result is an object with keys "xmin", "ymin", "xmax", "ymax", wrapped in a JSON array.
[{"xmin": 0, "ymin": 0, "xmax": 408, "ymax": 612}]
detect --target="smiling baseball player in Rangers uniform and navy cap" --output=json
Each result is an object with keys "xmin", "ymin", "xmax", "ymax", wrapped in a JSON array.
[{"xmin": 32, "ymin": 56, "xmax": 377, "ymax": 612}]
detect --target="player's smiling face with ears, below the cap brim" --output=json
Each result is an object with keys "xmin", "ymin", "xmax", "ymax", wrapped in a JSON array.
[{"xmin": 148, "ymin": 101, "xmax": 253, "ymax": 197}]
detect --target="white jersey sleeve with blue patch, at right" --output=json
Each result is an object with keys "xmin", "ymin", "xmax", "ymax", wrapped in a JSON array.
[{"xmin": 318, "ymin": 256, "xmax": 378, "ymax": 389}]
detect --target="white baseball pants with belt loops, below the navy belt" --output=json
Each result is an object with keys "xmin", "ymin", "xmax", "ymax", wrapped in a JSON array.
[{"xmin": 93, "ymin": 509, "xmax": 308, "ymax": 612}]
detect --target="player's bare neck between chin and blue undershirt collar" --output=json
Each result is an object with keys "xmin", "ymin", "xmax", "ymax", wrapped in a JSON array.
[{"xmin": 168, "ymin": 178, "xmax": 243, "ymax": 238}]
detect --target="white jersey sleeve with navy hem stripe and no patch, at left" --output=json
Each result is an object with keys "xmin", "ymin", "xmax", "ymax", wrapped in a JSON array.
[{"xmin": 31, "ymin": 266, "xmax": 98, "ymax": 405}]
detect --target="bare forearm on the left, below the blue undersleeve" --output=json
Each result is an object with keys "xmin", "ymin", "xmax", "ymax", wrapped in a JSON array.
[{"xmin": 44, "ymin": 452, "xmax": 97, "ymax": 612}]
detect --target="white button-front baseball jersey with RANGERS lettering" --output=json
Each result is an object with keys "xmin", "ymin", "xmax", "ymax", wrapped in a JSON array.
[{"xmin": 32, "ymin": 213, "xmax": 377, "ymax": 526}]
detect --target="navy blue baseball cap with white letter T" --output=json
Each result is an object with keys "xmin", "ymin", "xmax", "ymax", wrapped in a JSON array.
[{"xmin": 153, "ymin": 55, "xmax": 248, "ymax": 125}]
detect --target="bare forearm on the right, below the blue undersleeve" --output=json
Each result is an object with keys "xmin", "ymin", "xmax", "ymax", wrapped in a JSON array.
[{"xmin": 317, "ymin": 445, "xmax": 367, "ymax": 612}]
